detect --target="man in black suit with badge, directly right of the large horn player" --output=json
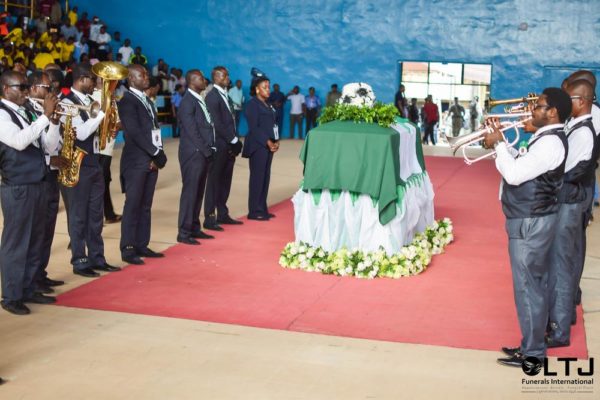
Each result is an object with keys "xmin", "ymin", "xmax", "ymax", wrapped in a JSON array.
[{"xmin": 118, "ymin": 65, "xmax": 167, "ymax": 264}]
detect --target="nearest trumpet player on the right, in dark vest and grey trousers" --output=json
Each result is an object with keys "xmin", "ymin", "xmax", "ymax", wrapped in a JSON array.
[{"xmin": 485, "ymin": 88, "xmax": 571, "ymax": 367}]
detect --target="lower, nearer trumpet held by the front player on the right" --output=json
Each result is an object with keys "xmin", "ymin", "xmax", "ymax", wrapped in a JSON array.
[{"xmin": 446, "ymin": 112, "xmax": 532, "ymax": 165}]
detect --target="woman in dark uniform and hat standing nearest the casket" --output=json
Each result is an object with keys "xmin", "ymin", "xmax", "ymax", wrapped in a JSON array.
[{"xmin": 242, "ymin": 70, "xmax": 279, "ymax": 221}]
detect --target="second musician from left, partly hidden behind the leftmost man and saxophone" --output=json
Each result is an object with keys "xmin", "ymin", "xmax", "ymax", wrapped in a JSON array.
[{"xmin": 25, "ymin": 71, "xmax": 68, "ymax": 293}]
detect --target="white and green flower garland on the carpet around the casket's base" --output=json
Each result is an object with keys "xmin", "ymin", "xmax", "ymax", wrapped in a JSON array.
[{"xmin": 279, "ymin": 218, "xmax": 454, "ymax": 279}]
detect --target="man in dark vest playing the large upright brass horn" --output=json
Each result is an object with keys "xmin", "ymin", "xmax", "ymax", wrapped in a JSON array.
[{"xmin": 62, "ymin": 64, "xmax": 120, "ymax": 277}]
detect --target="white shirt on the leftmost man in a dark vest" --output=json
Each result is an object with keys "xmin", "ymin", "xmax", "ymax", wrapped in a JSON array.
[{"xmin": 0, "ymin": 99, "xmax": 55, "ymax": 151}]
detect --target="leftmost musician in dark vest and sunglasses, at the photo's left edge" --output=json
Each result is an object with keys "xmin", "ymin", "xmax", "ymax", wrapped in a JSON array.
[{"xmin": 0, "ymin": 71, "xmax": 59, "ymax": 315}]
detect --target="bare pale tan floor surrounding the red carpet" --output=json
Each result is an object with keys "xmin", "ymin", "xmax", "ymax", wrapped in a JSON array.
[{"xmin": 0, "ymin": 140, "xmax": 600, "ymax": 399}]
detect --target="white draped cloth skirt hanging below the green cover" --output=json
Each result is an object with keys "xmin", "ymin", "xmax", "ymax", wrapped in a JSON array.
[{"xmin": 292, "ymin": 173, "xmax": 434, "ymax": 255}]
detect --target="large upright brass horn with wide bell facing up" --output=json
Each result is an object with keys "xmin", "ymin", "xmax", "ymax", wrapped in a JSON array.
[{"xmin": 92, "ymin": 61, "xmax": 129, "ymax": 150}]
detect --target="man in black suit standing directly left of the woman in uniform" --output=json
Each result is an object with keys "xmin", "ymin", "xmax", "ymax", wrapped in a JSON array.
[{"xmin": 204, "ymin": 66, "xmax": 242, "ymax": 231}]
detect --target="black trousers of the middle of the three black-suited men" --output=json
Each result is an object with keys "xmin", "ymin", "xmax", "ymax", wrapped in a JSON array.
[{"xmin": 178, "ymin": 152, "xmax": 210, "ymax": 237}]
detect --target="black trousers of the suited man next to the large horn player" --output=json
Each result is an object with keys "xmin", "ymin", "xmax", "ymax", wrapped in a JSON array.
[{"xmin": 120, "ymin": 168, "xmax": 158, "ymax": 257}]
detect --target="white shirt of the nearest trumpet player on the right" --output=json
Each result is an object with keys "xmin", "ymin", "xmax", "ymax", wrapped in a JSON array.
[{"xmin": 496, "ymin": 124, "xmax": 565, "ymax": 186}]
